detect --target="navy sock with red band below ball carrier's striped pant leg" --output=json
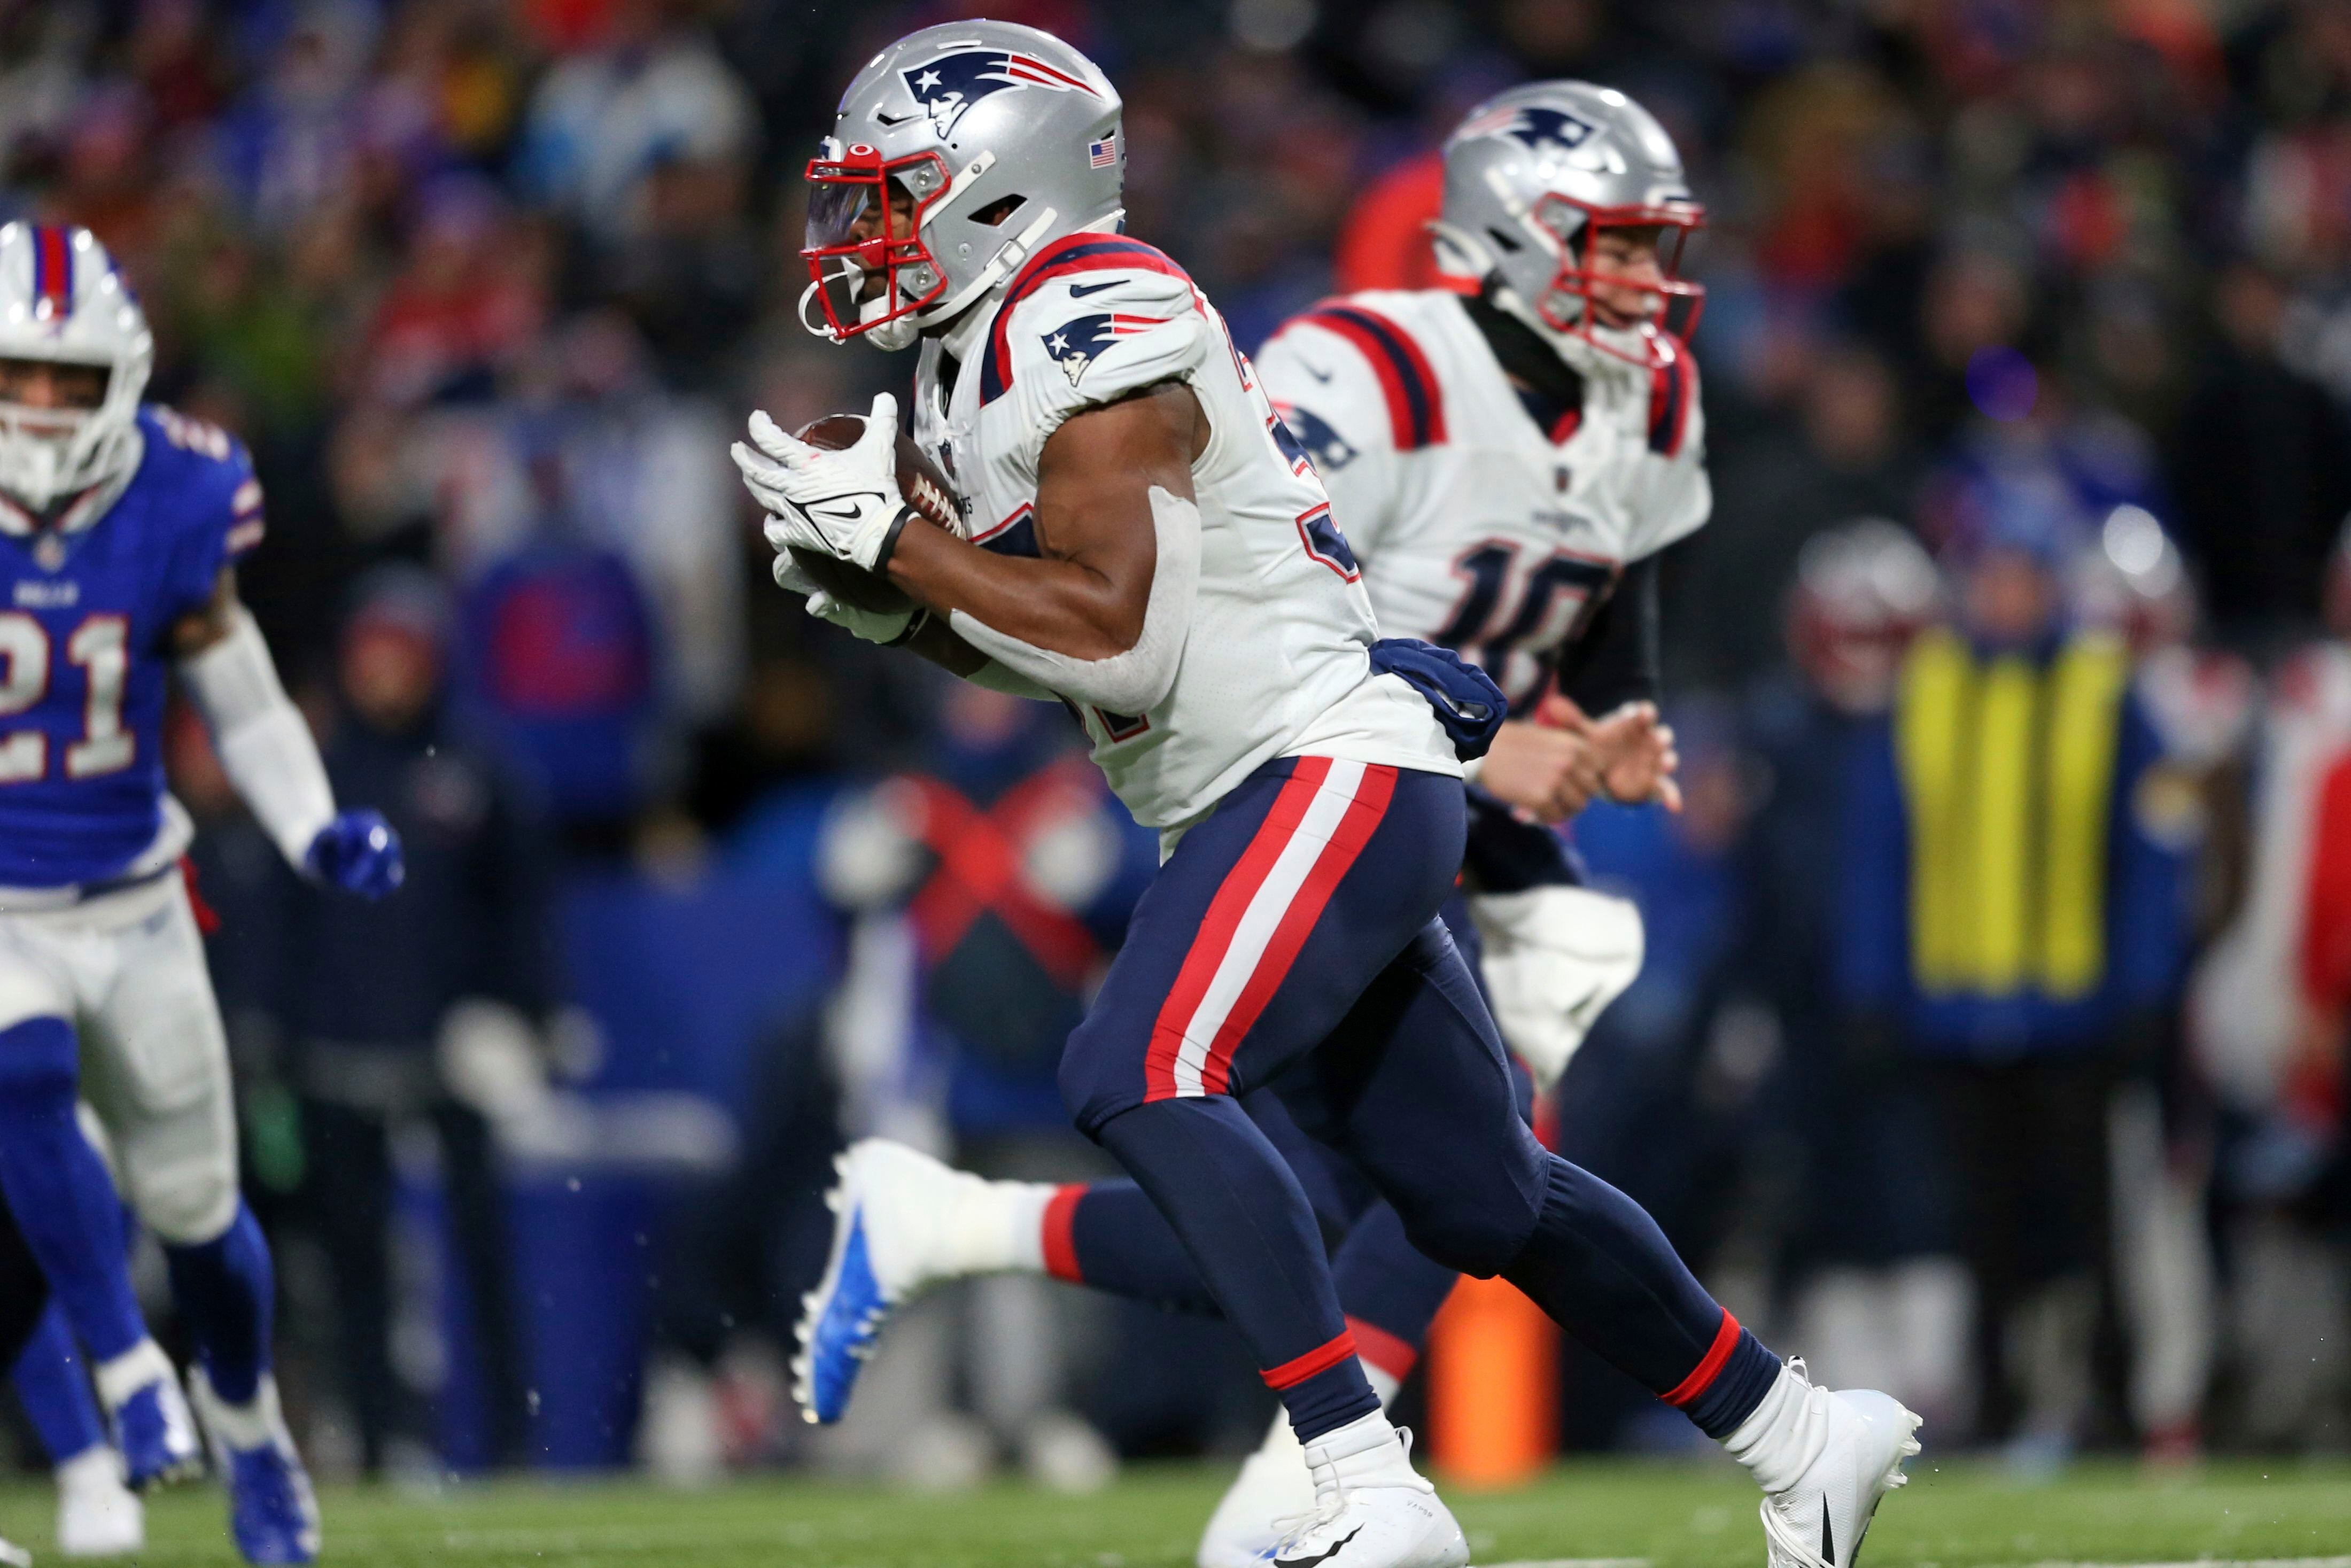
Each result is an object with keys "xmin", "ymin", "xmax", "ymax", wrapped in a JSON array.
[{"xmin": 1098, "ymin": 1096, "xmax": 1380, "ymax": 1441}]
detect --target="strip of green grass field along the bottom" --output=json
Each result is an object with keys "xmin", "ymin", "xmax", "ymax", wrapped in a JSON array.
[{"xmin": 0, "ymin": 1462, "xmax": 2351, "ymax": 1568}]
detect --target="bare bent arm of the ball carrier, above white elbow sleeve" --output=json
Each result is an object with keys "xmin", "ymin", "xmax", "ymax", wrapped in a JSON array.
[{"xmin": 889, "ymin": 383, "xmax": 1208, "ymax": 670}]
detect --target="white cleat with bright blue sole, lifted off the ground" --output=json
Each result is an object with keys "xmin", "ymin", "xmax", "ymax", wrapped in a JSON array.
[{"xmin": 792, "ymin": 1138, "xmax": 990, "ymax": 1425}]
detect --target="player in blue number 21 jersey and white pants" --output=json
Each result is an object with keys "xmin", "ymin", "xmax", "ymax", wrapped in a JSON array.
[{"xmin": 0, "ymin": 223, "xmax": 402, "ymax": 1563}]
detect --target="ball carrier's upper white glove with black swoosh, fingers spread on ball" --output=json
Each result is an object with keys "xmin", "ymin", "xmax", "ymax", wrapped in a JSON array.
[{"xmin": 729, "ymin": 393, "xmax": 914, "ymax": 571}]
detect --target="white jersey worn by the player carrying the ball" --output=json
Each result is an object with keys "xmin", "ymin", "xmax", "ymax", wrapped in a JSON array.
[{"xmin": 912, "ymin": 232, "xmax": 1460, "ymax": 827}]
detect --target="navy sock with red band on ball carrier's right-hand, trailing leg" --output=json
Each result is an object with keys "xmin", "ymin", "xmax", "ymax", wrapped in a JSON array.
[{"xmin": 1502, "ymin": 1154, "xmax": 1780, "ymax": 1439}]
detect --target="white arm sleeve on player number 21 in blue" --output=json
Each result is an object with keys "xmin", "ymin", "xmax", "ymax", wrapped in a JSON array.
[{"xmin": 179, "ymin": 604, "xmax": 334, "ymax": 870}]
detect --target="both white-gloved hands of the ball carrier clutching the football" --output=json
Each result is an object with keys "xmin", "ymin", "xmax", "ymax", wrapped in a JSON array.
[{"xmin": 733, "ymin": 393, "xmax": 964, "ymax": 614}]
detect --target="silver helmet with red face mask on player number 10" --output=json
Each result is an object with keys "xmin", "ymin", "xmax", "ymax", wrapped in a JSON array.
[{"xmin": 1434, "ymin": 82, "xmax": 1707, "ymax": 364}]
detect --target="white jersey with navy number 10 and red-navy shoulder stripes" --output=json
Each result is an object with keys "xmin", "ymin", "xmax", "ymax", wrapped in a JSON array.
[{"xmin": 1258, "ymin": 289, "xmax": 1714, "ymax": 710}]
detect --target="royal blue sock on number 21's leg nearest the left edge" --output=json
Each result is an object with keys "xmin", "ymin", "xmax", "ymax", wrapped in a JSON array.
[{"xmin": 0, "ymin": 1018, "xmax": 146, "ymax": 1361}]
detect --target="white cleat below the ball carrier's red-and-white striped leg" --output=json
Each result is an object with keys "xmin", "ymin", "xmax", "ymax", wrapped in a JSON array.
[{"xmin": 1262, "ymin": 1410, "xmax": 1469, "ymax": 1568}]
